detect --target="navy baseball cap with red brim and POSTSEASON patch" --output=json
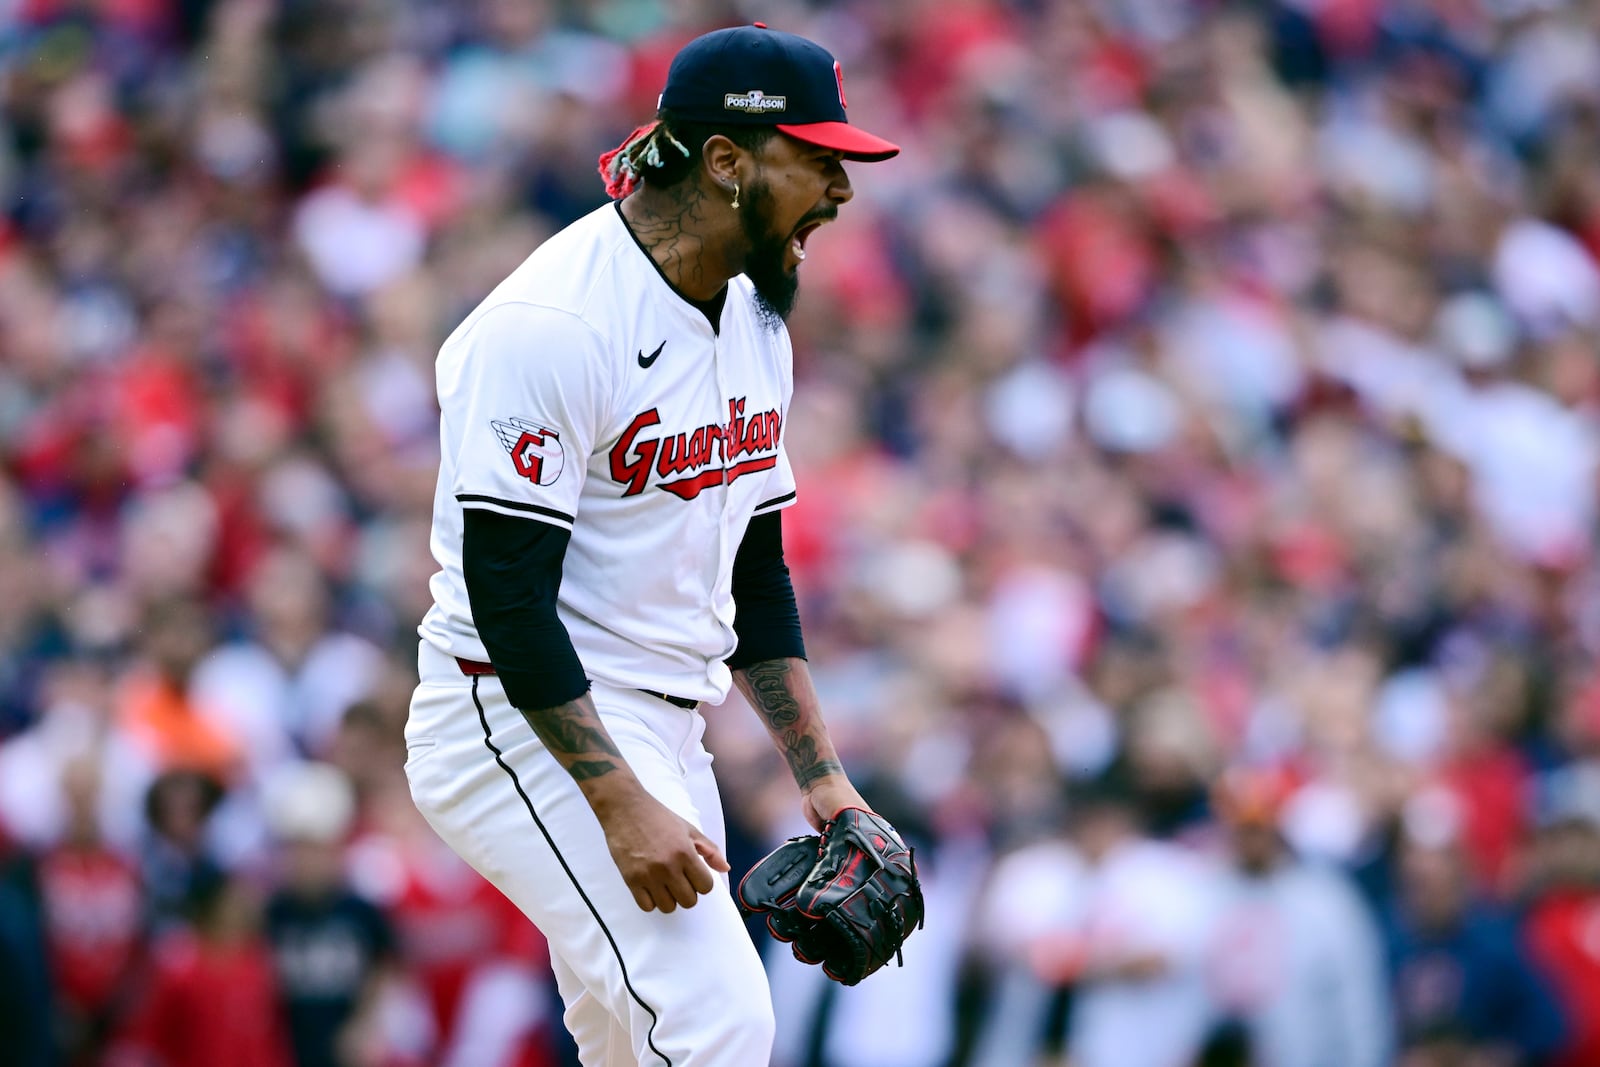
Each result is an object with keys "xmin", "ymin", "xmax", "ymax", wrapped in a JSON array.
[{"xmin": 661, "ymin": 22, "xmax": 899, "ymax": 163}]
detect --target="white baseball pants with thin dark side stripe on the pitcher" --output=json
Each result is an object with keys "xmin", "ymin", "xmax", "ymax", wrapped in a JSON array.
[{"xmin": 405, "ymin": 641, "xmax": 773, "ymax": 1067}]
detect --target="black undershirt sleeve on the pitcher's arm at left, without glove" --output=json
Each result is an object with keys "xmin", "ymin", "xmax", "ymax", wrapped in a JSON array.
[{"xmin": 461, "ymin": 507, "xmax": 589, "ymax": 710}]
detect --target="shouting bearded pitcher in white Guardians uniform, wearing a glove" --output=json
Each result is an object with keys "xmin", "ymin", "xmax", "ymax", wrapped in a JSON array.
[{"xmin": 406, "ymin": 24, "xmax": 922, "ymax": 1067}]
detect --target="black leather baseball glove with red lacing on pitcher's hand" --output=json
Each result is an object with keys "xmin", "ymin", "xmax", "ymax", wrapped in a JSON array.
[{"xmin": 738, "ymin": 808, "xmax": 923, "ymax": 985}]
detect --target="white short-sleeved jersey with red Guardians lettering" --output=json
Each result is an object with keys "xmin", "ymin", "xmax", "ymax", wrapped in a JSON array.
[{"xmin": 419, "ymin": 205, "xmax": 795, "ymax": 702}]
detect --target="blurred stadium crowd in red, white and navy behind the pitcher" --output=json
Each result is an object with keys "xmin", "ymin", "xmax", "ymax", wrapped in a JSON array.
[{"xmin": 0, "ymin": 0, "xmax": 1600, "ymax": 1067}]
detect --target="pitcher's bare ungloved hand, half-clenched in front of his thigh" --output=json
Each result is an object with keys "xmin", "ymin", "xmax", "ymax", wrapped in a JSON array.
[{"xmin": 592, "ymin": 782, "xmax": 728, "ymax": 912}]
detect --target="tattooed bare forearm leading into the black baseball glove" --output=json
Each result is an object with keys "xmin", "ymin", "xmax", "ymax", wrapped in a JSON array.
[{"xmin": 733, "ymin": 657, "xmax": 867, "ymax": 830}]
